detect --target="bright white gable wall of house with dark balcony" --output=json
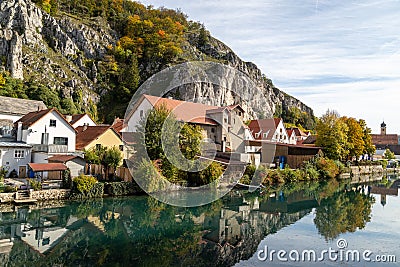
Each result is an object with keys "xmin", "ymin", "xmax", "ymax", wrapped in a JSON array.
[{"xmin": 22, "ymin": 111, "xmax": 76, "ymax": 152}]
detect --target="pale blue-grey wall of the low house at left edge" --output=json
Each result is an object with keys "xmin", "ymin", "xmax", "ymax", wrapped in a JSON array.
[{"xmin": 0, "ymin": 147, "xmax": 31, "ymax": 176}]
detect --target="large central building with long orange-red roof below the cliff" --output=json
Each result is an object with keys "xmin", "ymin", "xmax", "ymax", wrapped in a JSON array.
[{"xmin": 125, "ymin": 94, "xmax": 245, "ymax": 152}]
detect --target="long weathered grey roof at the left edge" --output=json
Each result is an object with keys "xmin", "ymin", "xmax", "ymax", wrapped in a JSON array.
[{"xmin": 0, "ymin": 96, "xmax": 47, "ymax": 116}]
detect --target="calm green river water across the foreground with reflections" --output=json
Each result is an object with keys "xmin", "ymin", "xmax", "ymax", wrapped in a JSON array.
[{"xmin": 0, "ymin": 177, "xmax": 400, "ymax": 266}]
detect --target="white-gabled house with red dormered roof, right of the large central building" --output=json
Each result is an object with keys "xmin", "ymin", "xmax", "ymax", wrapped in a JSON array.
[{"xmin": 248, "ymin": 118, "xmax": 290, "ymax": 144}]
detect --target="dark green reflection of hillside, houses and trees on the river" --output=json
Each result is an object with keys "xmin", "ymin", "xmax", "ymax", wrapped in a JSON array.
[{"xmin": 0, "ymin": 178, "xmax": 399, "ymax": 266}]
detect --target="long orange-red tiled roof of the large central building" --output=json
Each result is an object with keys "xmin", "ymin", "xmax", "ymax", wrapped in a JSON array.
[{"xmin": 143, "ymin": 95, "xmax": 221, "ymax": 125}]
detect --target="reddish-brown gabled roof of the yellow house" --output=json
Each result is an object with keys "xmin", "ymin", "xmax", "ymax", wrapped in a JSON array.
[{"xmin": 76, "ymin": 125, "xmax": 121, "ymax": 150}]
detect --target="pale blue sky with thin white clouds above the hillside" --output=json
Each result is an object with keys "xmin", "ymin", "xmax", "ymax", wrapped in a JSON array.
[{"xmin": 140, "ymin": 0, "xmax": 400, "ymax": 134}]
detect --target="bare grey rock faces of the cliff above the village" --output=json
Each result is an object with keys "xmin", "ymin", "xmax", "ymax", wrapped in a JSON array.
[{"xmin": 0, "ymin": 0, "xmax": 313, "ymax": 121}]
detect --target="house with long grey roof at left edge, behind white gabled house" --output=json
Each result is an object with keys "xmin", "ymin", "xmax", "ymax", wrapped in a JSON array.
[{"xmin": 0, "ymin": 96, "xmax": 47, "ymax": 137}]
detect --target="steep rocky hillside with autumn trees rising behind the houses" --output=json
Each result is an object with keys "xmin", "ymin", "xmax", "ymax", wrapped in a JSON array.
[{"xmin": 0, "ymin": 0, "xmax": 315, "ymax": 128}]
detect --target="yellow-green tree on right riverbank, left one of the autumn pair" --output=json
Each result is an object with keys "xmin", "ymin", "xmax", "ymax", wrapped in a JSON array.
[{"xmin": 315, "ymin": 110, "xmax": 348, "ymax": 160}]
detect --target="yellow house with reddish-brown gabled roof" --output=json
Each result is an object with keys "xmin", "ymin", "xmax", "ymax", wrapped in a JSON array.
[{"xmin": 76, "ymin": 125, "xmax": 124, "ymax": 154}]
